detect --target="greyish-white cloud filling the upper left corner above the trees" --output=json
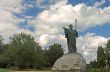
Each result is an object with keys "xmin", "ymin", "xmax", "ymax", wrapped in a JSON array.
[{"xmin": 0, "ymin": 0, "xmax": 31, "ymax": 42}]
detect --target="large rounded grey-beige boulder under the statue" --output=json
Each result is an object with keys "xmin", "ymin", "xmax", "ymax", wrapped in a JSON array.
[{"xmin": 52, "ymin": 53, "xmax": 86, "ymax": 72}]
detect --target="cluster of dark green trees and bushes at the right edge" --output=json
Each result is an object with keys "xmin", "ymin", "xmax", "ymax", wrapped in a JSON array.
[{"xmin": 90, "ymin": 40, "xmax": 110, "ymax": 68}]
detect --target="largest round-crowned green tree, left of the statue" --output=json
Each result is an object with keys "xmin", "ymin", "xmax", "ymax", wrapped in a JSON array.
[{"xmin": 5, "ymin": 33, "xmax": 39, "ymax": 68}]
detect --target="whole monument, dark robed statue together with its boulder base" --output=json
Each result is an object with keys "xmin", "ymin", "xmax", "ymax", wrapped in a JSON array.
[{"xmin": 52, "ymin": 20, "xmax": 86, "ymax": 72}]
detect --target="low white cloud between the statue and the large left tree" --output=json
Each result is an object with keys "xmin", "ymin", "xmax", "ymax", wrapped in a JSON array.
[{"xmin": 38, "ymin": 34, "xmax": 67, "ymax": 51}]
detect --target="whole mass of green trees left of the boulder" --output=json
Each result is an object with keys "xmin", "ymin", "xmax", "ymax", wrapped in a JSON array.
[{"xmin": 0, "ymin": 33, "xmax": 64, "ymax": 69}]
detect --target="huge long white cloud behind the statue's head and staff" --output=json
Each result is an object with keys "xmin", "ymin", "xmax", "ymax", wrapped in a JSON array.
[{"xmin": 35, "ymin": 0, "xmax": 110, "ymax": 34}]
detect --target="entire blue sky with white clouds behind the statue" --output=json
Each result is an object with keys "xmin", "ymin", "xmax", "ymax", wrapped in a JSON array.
[{"xmin": 0, "ymin": 0, "xmax": 110, "ymax": 63}]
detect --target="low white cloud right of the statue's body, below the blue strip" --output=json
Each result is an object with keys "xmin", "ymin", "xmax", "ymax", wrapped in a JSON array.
[{"xmin": 77, "ymin": 33, "xmax": 110, "ymax": 63}]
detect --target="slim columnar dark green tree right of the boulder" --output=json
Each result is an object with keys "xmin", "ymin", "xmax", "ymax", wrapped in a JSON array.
[{"xmin": 97, "ymin": 46, "xmax": 105, "ymax": 67}]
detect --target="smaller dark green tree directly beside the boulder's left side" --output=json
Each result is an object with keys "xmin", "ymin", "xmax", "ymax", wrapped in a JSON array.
[{"xmin": 45, "ymin": 44, "xmax": 64, "ymax": 66}]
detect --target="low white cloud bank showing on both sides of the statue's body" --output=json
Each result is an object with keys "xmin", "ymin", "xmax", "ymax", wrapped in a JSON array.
[{"xmin": 39, "ymin": 33, "xmax": 109, "ymax": 63}]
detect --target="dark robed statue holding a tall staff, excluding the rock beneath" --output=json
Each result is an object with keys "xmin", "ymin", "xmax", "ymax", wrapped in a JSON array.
[{"xmin": 63, "ymin": 20, "xmax": 78, "ymax": 53}]
